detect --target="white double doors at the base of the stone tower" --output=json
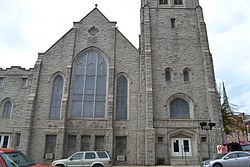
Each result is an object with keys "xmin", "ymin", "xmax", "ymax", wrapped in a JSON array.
[{"xmin": 171, "ymin": 138, "xmax": 192, "ymax": 157}]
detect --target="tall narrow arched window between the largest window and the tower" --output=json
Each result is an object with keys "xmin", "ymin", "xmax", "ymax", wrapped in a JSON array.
[{"xmin": 116, "ymin": 75, "xmax": 128, "ymax": 120}]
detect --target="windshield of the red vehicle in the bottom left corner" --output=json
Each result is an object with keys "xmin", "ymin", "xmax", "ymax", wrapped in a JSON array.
[{"xmin": 5, "ymin": 151, "xmax": 34, "ymax": 167}]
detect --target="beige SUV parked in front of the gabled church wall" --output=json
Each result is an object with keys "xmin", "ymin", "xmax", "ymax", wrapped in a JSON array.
[{"xmin": 52, "ymin": 151, "xmax": 112, "ymax": 167}]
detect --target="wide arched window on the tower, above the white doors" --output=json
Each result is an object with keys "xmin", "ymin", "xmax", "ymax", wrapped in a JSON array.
[{"xmin": 170, "ymin": 98, "xmax": 190, "ymax": 119}]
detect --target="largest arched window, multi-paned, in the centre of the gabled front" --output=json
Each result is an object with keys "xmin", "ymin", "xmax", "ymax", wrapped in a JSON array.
[{"xmin": 70, "ymin": 48, "xmax": 107, "ymax": 118}]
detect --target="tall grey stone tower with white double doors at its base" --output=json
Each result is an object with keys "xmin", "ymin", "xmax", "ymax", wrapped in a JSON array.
[{"xmin": 140, "ymin": 0, "xmax": 222, "ymax": 165}]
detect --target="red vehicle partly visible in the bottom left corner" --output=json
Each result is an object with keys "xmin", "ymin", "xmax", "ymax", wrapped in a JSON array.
[{"xmin": 0, "ymin": 148, "xmax": 51, "ymax": 167}]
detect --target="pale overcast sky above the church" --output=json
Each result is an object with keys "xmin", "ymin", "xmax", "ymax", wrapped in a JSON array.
[{"xmin": 0, "ymin": 0, "xmax": 250, "ymax": 114}]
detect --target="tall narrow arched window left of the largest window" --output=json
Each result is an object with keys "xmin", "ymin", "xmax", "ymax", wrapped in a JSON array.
[{"xmin": 49, "ymin": 75, "xmax": 64, "ymax": 119}]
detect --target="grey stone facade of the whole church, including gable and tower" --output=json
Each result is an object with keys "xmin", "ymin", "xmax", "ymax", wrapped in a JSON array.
[{"xmin": 0, "ymin": 0, "xmax": 222, "ymax": 165}]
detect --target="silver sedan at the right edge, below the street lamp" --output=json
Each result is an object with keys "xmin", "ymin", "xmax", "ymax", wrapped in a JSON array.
[{"xmin": 201, "ymin": 151, "xmax": 250, "ymax": 167}]
